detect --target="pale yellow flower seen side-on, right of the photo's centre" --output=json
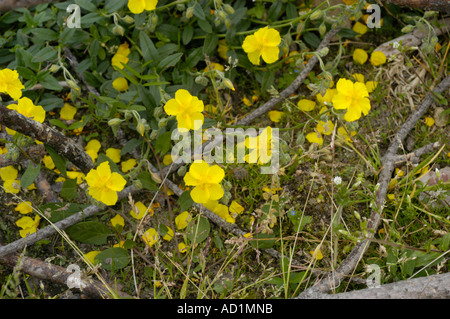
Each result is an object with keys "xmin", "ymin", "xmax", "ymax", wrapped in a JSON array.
[{"xmin": 245, "ymin": 126, "xmax": 273, "ymax": 165}]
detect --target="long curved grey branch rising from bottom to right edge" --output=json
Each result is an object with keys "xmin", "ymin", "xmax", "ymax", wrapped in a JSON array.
[{"xmin": 297, "ymin": 76, "xmax": 450, "ymax": 298}]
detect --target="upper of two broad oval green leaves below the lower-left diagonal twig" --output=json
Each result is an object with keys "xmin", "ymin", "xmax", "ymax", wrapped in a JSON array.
[{"xmin": 66, "ymin": 221, "xmax": 112, "ymax": 245}]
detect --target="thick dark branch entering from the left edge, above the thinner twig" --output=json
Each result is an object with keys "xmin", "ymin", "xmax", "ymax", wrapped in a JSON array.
[{"xmin": 0, "ymin": 104, "xmax": 94, "ymax": 174}]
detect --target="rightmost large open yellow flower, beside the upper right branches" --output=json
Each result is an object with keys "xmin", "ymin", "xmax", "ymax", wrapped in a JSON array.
[{"xmin": 333, "ymin": 79, "xmax": 370, "ymax": 122}]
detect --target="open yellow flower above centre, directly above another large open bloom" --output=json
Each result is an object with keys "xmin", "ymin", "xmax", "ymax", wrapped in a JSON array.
[{"xmin": 164, "ymin": 89, "xmax": 205, "ymax": 130}]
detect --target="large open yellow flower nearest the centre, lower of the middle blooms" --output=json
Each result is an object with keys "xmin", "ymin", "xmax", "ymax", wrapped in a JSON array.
[{"xmin": 184, "ymin": 161, "xmax": 225, "ymax": 204}]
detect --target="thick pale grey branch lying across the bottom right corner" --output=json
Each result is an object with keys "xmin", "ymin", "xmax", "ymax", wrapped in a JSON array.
[{"xmin": 298, "ymin": 272, "xmax": 450, "ymax": 299}]
